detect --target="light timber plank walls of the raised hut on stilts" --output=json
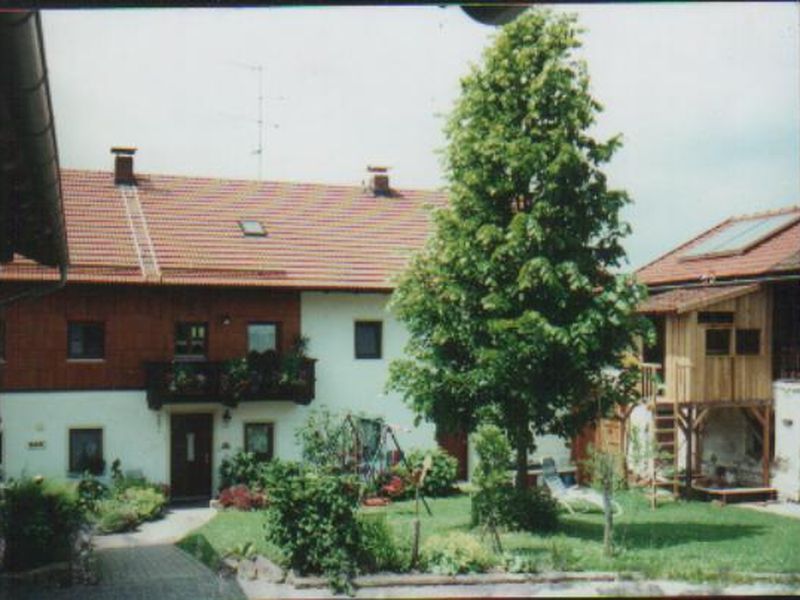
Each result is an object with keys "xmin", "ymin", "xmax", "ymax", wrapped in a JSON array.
[{"xmin": 665, "ymin": 287, "xmax": 772, "ymax": 403}]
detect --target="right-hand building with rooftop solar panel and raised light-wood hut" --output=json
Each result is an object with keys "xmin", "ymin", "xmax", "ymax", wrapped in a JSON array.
[{"xmin": 625, "ymin": 207, "xmax": 800, "ymax": 501}]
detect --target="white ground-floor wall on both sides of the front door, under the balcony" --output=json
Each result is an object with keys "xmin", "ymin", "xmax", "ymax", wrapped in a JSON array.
[{"xmin": 0, "ymin": 391, "xmax": 307, "ymax": 490}]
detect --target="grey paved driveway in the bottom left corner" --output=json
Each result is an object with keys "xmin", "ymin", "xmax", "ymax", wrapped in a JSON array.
[{"xmin": 0, "ymin": 545, "xmax": 245, "ymax": 600}]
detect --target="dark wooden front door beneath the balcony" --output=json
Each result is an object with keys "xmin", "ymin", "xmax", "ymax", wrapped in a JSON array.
[{"xmin": 170, "ymin": 414, "xmax": 213, "ymax": 499}]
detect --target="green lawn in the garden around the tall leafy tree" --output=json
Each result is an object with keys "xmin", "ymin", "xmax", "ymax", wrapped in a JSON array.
[{"xmin": 180, "ymin": 492, "xmax": 800, "ymax": 580}]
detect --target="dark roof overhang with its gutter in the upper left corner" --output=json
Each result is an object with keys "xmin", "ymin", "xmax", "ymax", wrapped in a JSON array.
[{"xmin": 0, "ymin": 11, "xmax": 69, "ymax": 307}]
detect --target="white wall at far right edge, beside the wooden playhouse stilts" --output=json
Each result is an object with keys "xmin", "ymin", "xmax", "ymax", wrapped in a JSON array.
[{"xmin": 772, "ymin": 381, "xmax": 800, "ymax": 502}]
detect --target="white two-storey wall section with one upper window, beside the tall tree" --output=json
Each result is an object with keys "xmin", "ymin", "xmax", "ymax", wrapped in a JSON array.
[{"xmin": 300, "ymin": 292, "xmax": 436, "ymax": 451}]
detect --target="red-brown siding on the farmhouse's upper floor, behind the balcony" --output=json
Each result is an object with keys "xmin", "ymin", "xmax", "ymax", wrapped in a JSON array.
[{"xmin": 2, "ymin": 285, "xmax": 300, "ymax": 391}]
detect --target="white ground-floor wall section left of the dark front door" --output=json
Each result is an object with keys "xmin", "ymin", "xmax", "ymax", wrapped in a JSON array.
[{"xmin": 0, "ymin": 391, "xmax": 169, "ymax": 482}]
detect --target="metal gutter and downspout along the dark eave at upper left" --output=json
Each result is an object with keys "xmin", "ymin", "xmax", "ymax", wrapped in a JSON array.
[{"xmin": 0, "ymin": 11, "xmax": 69, "ymax": 308}]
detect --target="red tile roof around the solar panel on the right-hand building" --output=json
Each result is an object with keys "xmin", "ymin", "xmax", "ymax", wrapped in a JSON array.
[{"xmin": 636, "ymin": 206, "xmax": 800, "ymax": 286}]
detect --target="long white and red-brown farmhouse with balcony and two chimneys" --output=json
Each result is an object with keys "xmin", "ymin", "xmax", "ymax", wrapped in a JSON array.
[{"xmin": 0, "ymin": 148, "xmax": 570, "ymax": 497}]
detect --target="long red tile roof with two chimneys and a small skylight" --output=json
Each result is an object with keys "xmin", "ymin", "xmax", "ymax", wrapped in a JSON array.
[{"xmin": 0, "ymin": 169, "xmax": 446, "ymax": 291}]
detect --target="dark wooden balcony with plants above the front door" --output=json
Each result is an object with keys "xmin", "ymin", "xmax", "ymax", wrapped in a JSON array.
[{"xmin": 145, "ymin": 358, "xmax": 316, "ymax": 410}]
